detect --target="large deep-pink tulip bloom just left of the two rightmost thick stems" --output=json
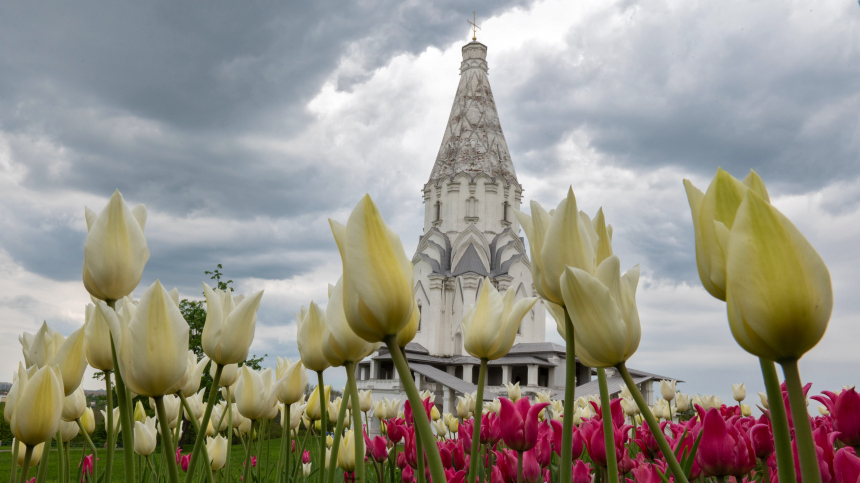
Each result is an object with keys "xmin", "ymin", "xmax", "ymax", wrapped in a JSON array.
[{"xmin": 696, "ymin": 409, "xmax": 755, "ymax": 477}]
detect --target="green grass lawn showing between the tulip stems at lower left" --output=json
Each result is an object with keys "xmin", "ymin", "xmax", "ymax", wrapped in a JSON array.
[{"xmin": 0, "ymin": 438, "xmax": 352, "ymax": 483}]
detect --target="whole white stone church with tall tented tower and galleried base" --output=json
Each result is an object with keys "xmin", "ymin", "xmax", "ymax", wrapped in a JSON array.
[{"xmin": 356, "ymin": 40, "xmax": 669, "ymax": 412}]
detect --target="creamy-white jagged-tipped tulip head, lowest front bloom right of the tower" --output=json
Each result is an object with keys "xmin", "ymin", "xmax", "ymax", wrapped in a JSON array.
[{"xmin": 561, "ymin": 255, "xmax": 642, "ymax": 367}]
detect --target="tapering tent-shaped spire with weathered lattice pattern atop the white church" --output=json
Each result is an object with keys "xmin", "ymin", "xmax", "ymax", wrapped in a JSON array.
[{"xmin": 430, "ymin": 41, "xmax": 517, "ymax": 182}]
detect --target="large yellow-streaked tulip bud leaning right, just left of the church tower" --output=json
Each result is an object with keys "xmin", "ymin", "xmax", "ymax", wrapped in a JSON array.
[{"xmin": 329, "ymin": 196, "xmax": 415, "ymax": 342}]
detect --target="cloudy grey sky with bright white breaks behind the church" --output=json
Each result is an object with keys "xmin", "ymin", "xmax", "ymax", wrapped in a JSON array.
[{"xmin": 0, "ymin": 0, "xmax": 860, "ymax": 410}]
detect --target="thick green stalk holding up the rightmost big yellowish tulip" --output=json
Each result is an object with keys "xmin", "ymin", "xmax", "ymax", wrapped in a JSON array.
[{"xmin": 784, "ymin": 359, "xmax": 821, "ymax": 483}]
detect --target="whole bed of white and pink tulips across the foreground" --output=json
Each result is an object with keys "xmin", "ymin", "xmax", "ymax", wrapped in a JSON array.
[{"xmin": 0, "ymin": 170, "xmax": 844, "ymax": 483}]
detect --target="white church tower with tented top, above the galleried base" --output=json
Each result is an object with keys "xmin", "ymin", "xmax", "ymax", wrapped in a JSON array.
[{"xmin": 412, "ymin": 41, "xmax": 546, "ymax": 356}]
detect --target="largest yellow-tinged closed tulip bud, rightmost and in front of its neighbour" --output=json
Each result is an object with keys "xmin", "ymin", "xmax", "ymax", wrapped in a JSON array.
[{"xmin": 726, "ymin": 190, "xmax": 833, "ymax": 361}]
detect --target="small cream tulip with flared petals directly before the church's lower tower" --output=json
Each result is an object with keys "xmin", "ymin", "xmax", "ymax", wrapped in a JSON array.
[{"xmin": 460, "ymin": 278, "xmax": 537, "ymax": 360}]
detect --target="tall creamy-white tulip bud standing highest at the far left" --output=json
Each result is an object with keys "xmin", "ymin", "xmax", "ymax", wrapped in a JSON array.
[{"xmin": 83, "ymin": 190, "xmax": 149, "ymax": 300}]
